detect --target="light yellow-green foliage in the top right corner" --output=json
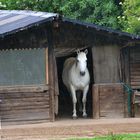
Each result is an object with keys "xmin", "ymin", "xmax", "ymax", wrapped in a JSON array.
[{"xmin": 120, "ymin": 0, "xmax": 140, "ymax": 35}]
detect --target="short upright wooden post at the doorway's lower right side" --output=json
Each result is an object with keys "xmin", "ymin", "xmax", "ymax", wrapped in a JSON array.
[{"xmin": 92, "ymin": 85, "xmax": 100, "ymax": 119}]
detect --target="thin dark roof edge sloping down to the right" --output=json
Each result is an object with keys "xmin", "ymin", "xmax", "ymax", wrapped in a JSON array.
[{"xmin": 62, "ymin": 17, "xmax": 140, "ymax": 41}]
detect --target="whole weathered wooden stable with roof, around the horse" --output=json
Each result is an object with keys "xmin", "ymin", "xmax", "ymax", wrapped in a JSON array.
[{"xmin": 0, "ymin": 10, "xmax": 140, "ymax": 123}]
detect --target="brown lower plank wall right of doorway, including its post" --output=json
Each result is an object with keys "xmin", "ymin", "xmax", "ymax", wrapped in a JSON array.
[{"xmin": 93, "ymin": 83, "xmax": 127, "ymax": 118}]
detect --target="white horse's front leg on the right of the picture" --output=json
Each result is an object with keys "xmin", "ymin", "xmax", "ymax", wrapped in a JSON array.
[{"xmin": 82, "ymin": 85, "xmax": 89, "ymax": 117}]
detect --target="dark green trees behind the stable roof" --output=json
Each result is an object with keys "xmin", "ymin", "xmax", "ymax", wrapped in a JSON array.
[{"xmin": 0, "ymin": 0, "xmax": 121, "ymax": 29}]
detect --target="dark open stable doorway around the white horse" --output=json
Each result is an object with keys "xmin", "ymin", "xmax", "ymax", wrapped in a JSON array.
[{"xmin": 56, "ymin": 48, "xmax": 93, "ymax": 118}]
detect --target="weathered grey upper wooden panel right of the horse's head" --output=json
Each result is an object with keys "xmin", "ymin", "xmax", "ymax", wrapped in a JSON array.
[{"xmin": 92, "ymin": 45, "xmax": 120, "ymax": 84}]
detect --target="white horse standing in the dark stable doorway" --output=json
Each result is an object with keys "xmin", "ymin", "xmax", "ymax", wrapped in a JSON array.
[{"xmin": 62, "ymin": 49, "xmax": 90, "ymax": 118}]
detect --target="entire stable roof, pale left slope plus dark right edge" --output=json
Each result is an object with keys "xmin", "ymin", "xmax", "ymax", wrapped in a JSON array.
[{"xmin": 0, "ymin": 10, "xmax": 140, "ymax": 42}]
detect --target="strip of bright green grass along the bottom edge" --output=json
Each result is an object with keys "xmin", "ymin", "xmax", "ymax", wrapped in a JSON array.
[{"xmin": 70, "ymin": 134, "xmax": 140, "ymax": 140}]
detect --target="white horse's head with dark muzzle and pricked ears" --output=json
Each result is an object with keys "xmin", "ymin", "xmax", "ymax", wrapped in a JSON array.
[{"xmin": 76, "ymin": 49, "xmax": 88, "ymax": 76}]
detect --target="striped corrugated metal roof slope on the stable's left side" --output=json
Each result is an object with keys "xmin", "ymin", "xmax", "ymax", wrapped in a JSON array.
[{"xmin": 0, "ymin": 10, "xmax": 58, "ymax": 37}]
